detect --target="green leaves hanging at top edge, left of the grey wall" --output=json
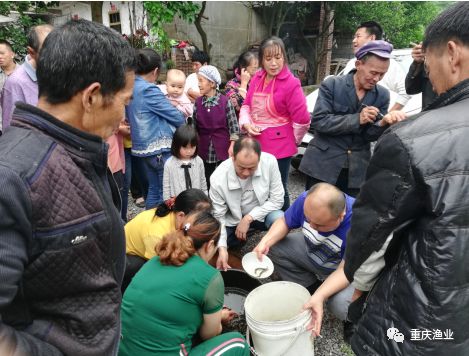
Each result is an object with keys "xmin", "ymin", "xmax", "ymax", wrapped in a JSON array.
[{"xmin": 143, "ymin": 1, "xmax": 200, "ymax": 52}]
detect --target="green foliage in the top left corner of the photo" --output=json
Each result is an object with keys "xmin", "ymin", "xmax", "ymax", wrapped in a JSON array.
[{"xmin": 0, "ymin": 1, "xmax": 47, "ymax": 58}]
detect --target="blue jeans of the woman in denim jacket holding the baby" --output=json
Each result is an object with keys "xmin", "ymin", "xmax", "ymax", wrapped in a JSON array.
[{"xmin": 143, "ymin": 152, "xmax": 171, "ymax": 210}]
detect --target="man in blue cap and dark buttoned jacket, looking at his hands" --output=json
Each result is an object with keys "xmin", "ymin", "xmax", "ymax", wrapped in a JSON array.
[{"xmin": 299, "ymin": 41, "xmax": 406, "ymax": 196}]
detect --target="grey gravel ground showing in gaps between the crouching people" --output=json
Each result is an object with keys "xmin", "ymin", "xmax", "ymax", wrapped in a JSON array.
[{"xmin": 128, "ymin": 168, "xmax": 354, "ymax": 356}]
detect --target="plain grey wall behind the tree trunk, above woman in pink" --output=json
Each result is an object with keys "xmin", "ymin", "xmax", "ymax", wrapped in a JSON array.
[{"xmin": 166, "ymin": 1, "xmax": 267, "ymax": 76}]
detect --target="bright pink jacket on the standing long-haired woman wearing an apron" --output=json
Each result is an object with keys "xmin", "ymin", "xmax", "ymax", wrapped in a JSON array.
[{"xmin": 239, "ymin": 65, "xmax": 311, "ymax": 158}]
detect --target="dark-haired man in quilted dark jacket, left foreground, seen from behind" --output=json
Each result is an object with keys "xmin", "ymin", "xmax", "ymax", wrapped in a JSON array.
[{"xmin": 0, "ymin": 20, "xmax": 135, "ymax": 356}]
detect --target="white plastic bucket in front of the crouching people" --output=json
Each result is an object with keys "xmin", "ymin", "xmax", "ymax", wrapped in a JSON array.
[{"xmin": 244, "ymin": 281, "xmax": 314, "ymax": 356}]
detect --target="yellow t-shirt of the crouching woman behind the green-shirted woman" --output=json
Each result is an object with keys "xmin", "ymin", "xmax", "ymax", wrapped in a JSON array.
[{"xmin": 125, "ymin": 209, "xmax": 176, "ymax": 260}]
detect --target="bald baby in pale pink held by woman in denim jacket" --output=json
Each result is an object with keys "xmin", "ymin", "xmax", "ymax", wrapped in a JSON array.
[{"xmin": 158, "ymin": 69, "xmax": 194, "ymax": 120}]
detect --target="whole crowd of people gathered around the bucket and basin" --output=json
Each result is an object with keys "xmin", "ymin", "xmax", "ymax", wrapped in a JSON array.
[{"xmin": 0, "ymin": 2, "xmax": 469, "ymax": 355}]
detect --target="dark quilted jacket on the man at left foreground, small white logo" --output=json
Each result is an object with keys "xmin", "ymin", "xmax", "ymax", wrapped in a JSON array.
[{"xmin": 0, "ymin": 104, "xmax": 125, "ymax": 356}]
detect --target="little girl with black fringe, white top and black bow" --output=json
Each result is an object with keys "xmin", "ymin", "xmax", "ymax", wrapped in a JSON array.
[{"xmin": 163, "ymin": 123, "xmax": 208, "ymax": 201}]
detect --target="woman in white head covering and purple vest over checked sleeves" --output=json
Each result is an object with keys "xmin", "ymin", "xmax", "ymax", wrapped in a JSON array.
[{"xmin": 194, "ymin": 65, "xmax": 239, "ymax": 188}]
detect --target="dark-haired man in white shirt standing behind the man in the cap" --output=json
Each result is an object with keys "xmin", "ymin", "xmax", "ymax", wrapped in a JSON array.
[{"xmin": 343, "ymin": 21, "xmax": 410, "ymax": 111}]
